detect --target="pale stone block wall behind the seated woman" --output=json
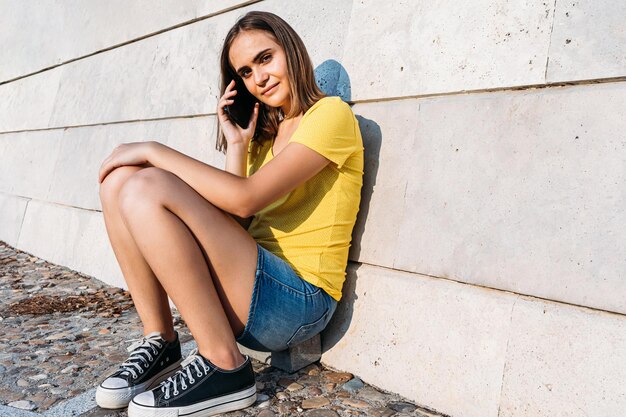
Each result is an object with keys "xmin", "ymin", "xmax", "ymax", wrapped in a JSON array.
[{"xmin": 0, "ymin": 0, "xmax": 626, "ymax": 417}]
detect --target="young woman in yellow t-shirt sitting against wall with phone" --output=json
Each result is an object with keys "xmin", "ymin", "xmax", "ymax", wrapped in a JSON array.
[{"xmin": 96, "ymin": 12, "xmax": 363, "ymax": 416}]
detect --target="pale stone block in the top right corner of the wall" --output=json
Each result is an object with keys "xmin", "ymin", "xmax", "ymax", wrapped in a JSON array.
[{"xmin": 546, "ymin": 0, "xmax": 626, "ymax": 82}]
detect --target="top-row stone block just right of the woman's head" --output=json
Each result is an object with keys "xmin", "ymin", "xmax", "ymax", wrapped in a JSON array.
[{"xmin": 342, "ymin": 0, "xmax": 554, "ymax": 100}]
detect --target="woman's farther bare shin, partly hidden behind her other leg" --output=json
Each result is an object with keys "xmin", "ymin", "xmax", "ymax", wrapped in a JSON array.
[{"xmin": 100, "ymin": 166, "xmax": 175, "ymax": 340}]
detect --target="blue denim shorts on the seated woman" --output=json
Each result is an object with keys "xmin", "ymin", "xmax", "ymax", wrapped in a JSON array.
[{"xmin": 237, "ymin": 244, "xmax": 337, "ymax": 352}]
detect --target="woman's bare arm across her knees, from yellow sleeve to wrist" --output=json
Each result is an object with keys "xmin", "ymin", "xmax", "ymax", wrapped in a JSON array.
[{"xmin": 147, "ymin": 142, "xmax": 329, "ymax": 218}]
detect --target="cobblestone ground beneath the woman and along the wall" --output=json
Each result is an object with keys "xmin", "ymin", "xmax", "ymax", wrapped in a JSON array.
[{"xmin": 0, "ymin": 242, "xmax": 439, "ymax": 417}]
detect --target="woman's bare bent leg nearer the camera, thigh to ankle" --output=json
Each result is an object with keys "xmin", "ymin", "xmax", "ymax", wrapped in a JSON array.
[{"xmin": 119, "ymin": 168, "xmax": 257, "ymax": 369}]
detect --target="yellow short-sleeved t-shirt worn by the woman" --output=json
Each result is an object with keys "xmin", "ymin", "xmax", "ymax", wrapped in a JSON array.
[{"xmin": 248, "ymin": 97, "xmax": 363, "ymax": 300}]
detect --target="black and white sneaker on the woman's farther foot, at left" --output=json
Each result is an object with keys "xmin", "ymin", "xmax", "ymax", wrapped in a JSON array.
[{"xmin": 96, "ymin": 332, "xmax": 181, "ymax": 408}]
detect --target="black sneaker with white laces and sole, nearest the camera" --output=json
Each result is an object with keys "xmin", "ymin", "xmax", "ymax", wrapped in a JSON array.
[{"xmin": 128, "ymin": 350, "xmax": 256, "ymax": 417}]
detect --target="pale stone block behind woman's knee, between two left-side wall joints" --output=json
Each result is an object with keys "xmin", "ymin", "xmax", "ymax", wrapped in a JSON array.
[{"xmin": 0, "ymin": 116, "xmax": 225, "ymax": 210}]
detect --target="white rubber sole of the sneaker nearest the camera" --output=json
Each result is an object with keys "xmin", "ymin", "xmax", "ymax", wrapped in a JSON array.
[{"xmin": 128, "ymin": 385, "xmax": 256, "ymax": 417}]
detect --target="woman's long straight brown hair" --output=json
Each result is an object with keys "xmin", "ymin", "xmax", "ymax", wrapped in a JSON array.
[{"xmin": 216, "ymin": 12, "xmax": 325, "ymax": 152}]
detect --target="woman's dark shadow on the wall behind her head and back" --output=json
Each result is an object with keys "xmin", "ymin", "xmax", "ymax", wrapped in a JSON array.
[{"xmin": 315, "ymin": 59, "xmax": 382, "ymax": 352}]
